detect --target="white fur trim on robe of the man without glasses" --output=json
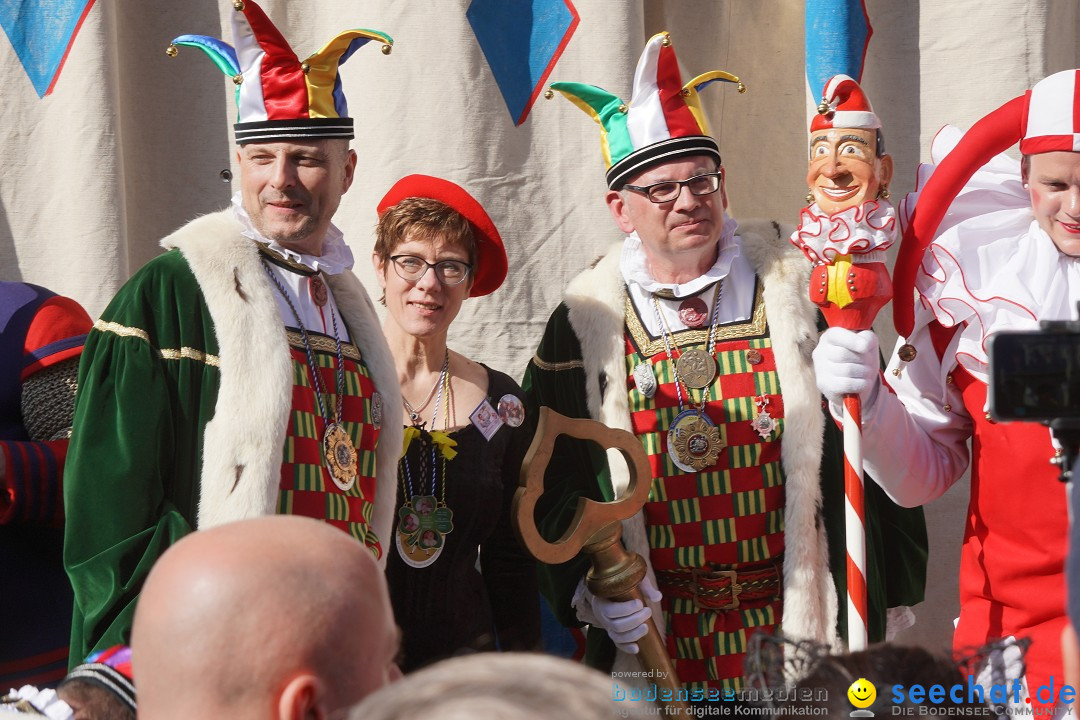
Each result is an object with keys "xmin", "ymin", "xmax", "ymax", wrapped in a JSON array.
[{"xmin": 161, "ymin": 209, "xmax": 402, "ymax": 562}]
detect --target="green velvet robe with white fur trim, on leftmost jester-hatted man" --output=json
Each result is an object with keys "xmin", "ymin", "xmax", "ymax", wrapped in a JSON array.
[{"xmin": 64, "ymin": 210, "xmax": 402, "ymax": 664}]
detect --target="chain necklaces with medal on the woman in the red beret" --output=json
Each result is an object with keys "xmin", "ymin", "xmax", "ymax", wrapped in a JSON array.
[{"xmin": 394, "ymin": 349, "xmax": 457, "ymax": 568}]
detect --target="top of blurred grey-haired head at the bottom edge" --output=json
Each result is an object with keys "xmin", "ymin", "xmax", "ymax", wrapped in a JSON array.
[{"xmin": 349, "ymin": 653, "xmax": 659, "ymax": 720}]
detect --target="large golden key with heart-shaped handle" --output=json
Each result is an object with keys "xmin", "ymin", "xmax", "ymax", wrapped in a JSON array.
[{"xmin": 513, "ymin": 407, "xmax": 685, "ymax": 715}]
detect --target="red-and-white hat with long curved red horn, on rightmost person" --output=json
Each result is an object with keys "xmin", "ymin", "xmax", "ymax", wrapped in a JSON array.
[{"xmin": 892, "ymin": 69, "xmax": 1080, "ymax": 337}]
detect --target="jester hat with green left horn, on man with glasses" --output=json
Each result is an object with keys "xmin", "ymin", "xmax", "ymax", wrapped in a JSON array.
[{"xmin": 549, "ymin": 32, "xmax": 746, "ymax": 190}]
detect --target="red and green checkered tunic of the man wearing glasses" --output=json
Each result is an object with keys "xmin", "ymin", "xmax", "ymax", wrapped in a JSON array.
[{"xmin": 626, "ymin": 323, "xmax": 784, "ymax": 690}]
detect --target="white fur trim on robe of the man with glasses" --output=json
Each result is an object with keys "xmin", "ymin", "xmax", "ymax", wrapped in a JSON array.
[{"xmin": 564, "ymin": 221, "xmax": 837, "ymax": 668}]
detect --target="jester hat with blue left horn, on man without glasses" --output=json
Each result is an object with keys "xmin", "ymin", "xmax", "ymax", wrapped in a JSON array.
[{"xmin": 167, "ymin": 0, "xmax": 393, "ymax": 145}]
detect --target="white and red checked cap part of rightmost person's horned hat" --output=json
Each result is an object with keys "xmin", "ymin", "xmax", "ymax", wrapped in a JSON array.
[{"xmin": 1020, "ymin": 70, "xmax": 1080, "ymax": 155}]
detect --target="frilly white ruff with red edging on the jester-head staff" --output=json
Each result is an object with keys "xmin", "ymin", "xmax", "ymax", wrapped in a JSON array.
[{"xmin": 792, "ymin": 200, "xmax": 900, "ymax": 264}]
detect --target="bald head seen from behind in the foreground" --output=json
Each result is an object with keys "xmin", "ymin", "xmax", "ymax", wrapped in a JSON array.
[{"xmin": 132, "ymin": 516, "xmax": 399, "ymax": 720}]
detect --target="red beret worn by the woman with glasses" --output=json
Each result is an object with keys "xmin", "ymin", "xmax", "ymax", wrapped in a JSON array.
[{"xmin": 376, "ymin": 175, "xmax": 507, "ymax": 298}]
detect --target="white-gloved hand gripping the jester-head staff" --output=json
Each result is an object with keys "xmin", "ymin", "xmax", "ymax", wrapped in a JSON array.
[{"xmin": 813, "ymin": 327, "xmax": 881, "ymax": 415}]
